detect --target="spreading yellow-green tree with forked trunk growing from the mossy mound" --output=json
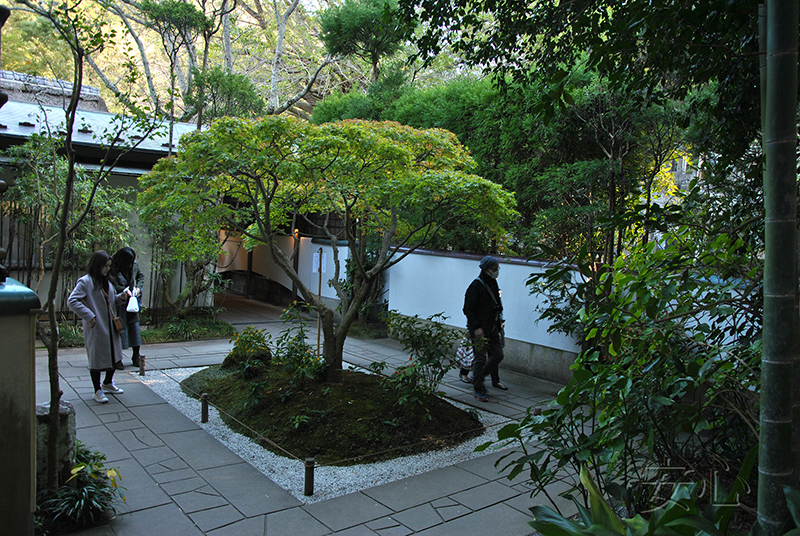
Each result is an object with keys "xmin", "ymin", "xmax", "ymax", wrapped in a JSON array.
[{"xmin": 148, "ymin": 116, "xmax": 514, "ymax": 371}]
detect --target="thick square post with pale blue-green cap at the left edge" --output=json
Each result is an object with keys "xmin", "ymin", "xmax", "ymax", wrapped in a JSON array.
[{"xmin": 0, "ymin": 278, "xmax": 41, "ymax": 536}]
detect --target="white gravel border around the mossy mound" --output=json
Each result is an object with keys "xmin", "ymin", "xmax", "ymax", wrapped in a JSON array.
[{"xmin": 137, "ymin": 368, "xmax": 508, "ymax": 503}]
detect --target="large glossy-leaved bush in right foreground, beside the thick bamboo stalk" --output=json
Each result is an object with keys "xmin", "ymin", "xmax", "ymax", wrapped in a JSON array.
[{"xmin": 488, "ymin": 184, "xmax": 761, "ymax": 512}]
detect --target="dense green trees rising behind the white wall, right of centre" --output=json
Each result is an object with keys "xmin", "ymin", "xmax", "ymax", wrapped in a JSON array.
[{"xmin": 314, "ymin": 72, "xmax": 683, "ymax": 257}]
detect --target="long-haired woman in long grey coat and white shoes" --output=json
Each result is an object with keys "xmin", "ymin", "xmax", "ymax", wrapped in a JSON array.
[{"xmin": 67, "ymin": 250, "xmax": 130, "ymax": 404}]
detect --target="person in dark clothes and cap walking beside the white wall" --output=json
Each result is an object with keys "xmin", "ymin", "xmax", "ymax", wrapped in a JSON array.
[{"xmin": 464, "ymin": 256, "xmax": 508, "ymax": 402}]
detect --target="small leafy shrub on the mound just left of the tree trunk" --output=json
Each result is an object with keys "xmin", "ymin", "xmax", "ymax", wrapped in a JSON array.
[{"xmin": 275, "ymin": 303, "xmax": 325, "ymax": 388}]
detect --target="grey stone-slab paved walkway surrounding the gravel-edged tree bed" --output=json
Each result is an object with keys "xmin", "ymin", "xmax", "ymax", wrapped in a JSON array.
[{"xmin": 36, "ymin": 295, "xmax": 572, "ymax": 536}]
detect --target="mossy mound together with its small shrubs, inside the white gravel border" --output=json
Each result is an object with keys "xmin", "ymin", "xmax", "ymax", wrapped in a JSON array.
[{"xmin": 181, "ymin": 307, "xmax": 484, "ymax": 465}]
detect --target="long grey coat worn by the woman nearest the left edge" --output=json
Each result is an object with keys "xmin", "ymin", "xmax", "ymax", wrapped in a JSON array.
[{"xmin": 67, "ymin": 274, "xmax": 126, "ymax": 370}]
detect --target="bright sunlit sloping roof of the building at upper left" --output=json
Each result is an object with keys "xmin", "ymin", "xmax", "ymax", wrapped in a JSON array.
[{"xmin": 0, "ymin": 101, "xmax": 197, "ymax": 170}]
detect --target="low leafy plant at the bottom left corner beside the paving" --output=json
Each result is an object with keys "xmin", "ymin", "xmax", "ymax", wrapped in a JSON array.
[{"xmin": 35, "ymin": 440, "xmax": 124, "ymax": 535}]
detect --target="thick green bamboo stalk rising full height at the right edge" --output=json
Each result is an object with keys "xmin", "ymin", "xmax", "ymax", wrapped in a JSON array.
[{"xmin": 758, "ymin": 0, "xmax": 800, "ymax": 536}]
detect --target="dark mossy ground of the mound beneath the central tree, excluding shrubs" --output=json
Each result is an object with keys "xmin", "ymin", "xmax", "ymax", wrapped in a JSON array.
[{"xmin": 182, "ymin": 365, "xmax": 483, "ymax": 465}]
